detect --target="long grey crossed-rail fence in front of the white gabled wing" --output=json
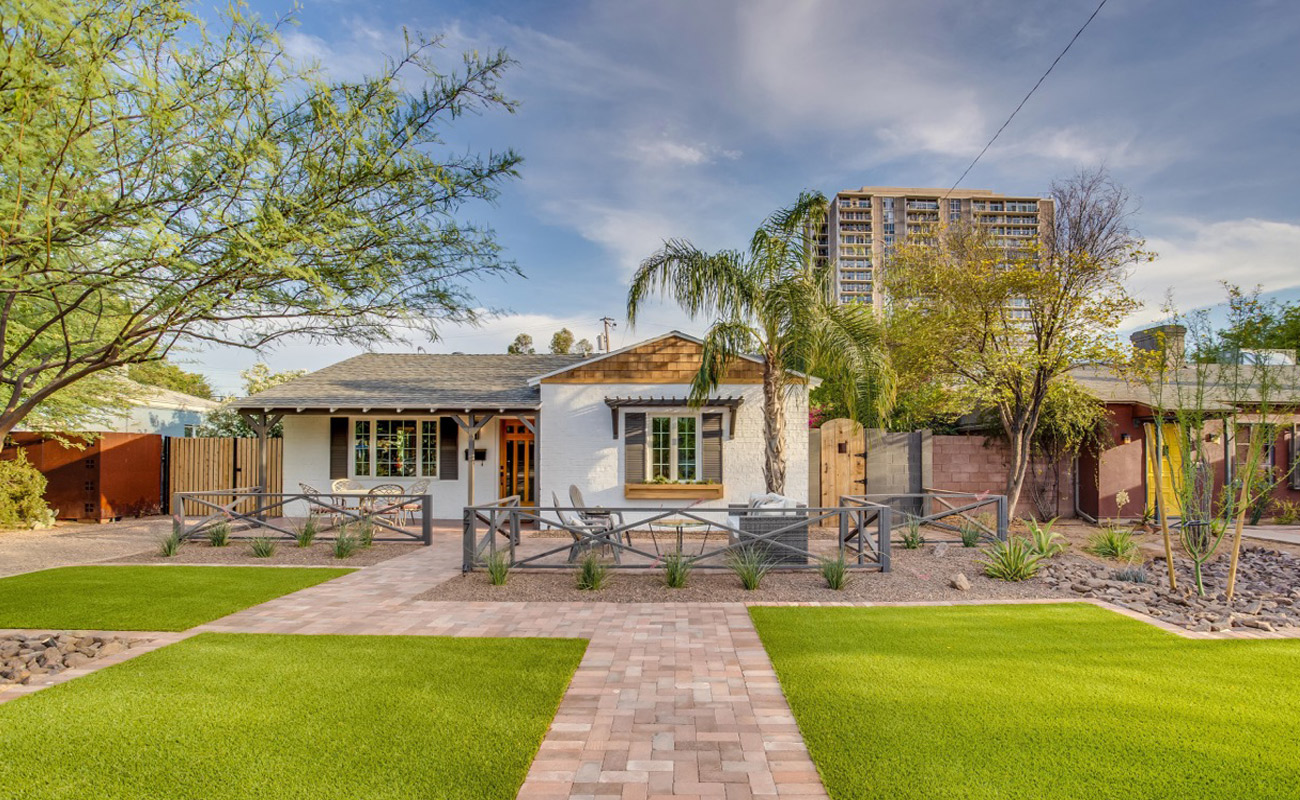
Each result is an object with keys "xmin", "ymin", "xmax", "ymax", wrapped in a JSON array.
[{"xmin": 462, "ymin": 497, "xmax": 892, "ymax": 572}]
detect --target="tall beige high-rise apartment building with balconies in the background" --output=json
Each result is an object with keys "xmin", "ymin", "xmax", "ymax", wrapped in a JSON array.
[{"xmin": 818, "ymin": 186, "xmax": 1054, "ymax": 310}]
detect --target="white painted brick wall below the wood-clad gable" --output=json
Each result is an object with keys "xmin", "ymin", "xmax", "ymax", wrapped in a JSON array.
[{"xmin": 538, "ymin": 384, "xmax": 809, "ymax": 522}]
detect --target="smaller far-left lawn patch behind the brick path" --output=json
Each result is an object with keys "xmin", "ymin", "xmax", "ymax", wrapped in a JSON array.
[{"xmin": 0, "ymin": 566, "xmax": 352, "ymax": 631}]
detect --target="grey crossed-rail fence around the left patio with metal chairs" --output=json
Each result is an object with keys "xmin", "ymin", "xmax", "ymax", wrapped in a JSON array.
[{"xmin": 172, "ymin": 487, "xmax": 433, "ymax": 545}]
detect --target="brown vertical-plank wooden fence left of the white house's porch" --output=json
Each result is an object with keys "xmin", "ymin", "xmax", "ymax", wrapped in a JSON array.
[{"xmin": 166, "ymin": 437, "xmax": 285, "ymax": 515}]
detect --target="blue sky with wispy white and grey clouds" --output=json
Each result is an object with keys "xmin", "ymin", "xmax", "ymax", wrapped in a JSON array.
[{"xmin": 192, "ymin": 0, "xmax": 1300, "ymax": 394}]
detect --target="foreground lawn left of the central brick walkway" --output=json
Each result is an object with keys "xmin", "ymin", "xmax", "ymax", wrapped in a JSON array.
[{"xmin": 0, "ymin": 633, "xmax": 586, "ymax": 800}]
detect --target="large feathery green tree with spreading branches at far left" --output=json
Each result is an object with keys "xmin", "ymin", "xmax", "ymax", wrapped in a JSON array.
[{"xmin": 0, "ymin": 0, "xmax": 519, "ymax": 447}]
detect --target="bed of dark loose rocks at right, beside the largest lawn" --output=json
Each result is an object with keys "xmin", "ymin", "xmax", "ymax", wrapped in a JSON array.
[{"xmin": 1040, "ymin": 546, "xmax": 1300, "ymax": 632}]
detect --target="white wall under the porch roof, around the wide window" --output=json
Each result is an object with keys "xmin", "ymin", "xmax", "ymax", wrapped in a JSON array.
[{"xmin": 283, "ymin": 414, "xmax": 501, "ymax": 519}]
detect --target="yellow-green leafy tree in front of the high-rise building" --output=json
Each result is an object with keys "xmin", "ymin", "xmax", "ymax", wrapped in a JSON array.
[{"xmin": 883, "ymin": 172, "xmax": 1145, "ymax": 517}]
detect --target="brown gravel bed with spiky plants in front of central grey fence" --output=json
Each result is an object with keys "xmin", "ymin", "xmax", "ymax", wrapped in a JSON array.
[{"xmin": 415, "ymin": 546, "xmax": 1066, "ymax": 602}]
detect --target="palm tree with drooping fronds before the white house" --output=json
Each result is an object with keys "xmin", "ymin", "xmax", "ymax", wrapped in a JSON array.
[{"xmin": 628, "ymin": 191, "xmax": 893, "ymax": 493}]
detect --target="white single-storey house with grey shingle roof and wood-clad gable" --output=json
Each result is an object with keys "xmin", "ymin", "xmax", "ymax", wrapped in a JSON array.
[{"xmin": 233, "ymin": 332, "xmax": 807, "ymax": 518}]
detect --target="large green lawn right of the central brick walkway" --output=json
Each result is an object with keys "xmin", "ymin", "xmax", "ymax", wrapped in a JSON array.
[{"xmin": 751, "ymin": 604, "xmax": 1300, "ymax": 800}]
